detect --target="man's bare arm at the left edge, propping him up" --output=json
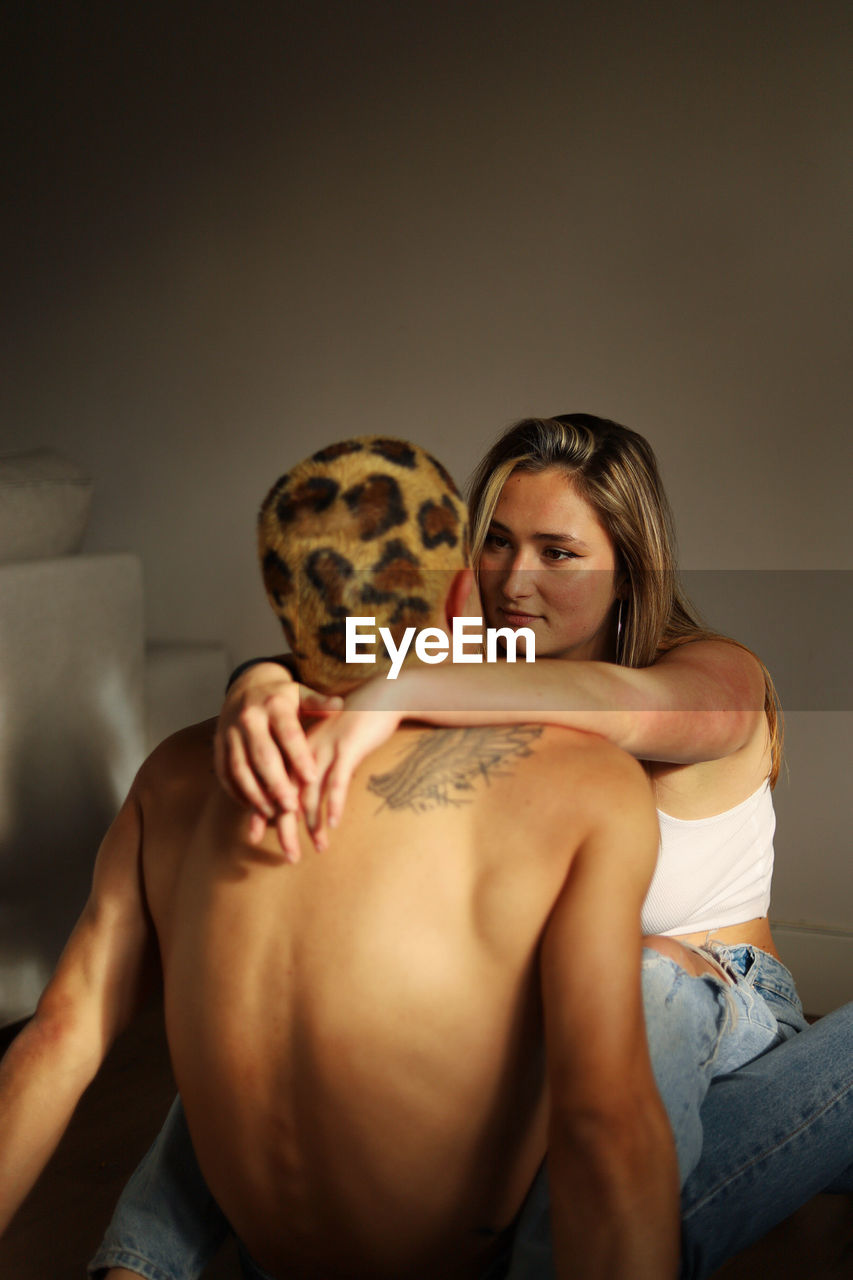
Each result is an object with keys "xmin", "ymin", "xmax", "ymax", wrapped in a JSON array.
[{"xmin": 0, "ymin": 788, "xmax": 156, "ymax": 1233}]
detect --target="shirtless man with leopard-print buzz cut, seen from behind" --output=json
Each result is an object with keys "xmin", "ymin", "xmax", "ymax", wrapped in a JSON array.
[{"xmin": 0, "ymin": 438, "xmax": 679, "ymax": 1280}]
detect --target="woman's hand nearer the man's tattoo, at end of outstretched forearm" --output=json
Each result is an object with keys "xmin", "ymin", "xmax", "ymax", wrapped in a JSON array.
[{"xmin": 300, "ymin": 676, "xmax": 403, "ymax": 850}]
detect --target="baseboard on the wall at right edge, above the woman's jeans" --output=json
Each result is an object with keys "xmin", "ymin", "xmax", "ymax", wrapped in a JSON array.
[{"xmin": 771, "ymin": 920, "xmax": 853, "ymax": 1016}]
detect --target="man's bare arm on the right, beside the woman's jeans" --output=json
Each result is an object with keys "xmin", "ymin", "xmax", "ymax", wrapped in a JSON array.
[{"xmin": 540, "ymin": 751, "xmax": 679, "ymax": 1280}]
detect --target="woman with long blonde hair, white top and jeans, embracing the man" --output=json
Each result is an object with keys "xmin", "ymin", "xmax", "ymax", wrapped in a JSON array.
[{"xmin": 89, "ymin": 415, "xmax": 853, "ymax": 1280}]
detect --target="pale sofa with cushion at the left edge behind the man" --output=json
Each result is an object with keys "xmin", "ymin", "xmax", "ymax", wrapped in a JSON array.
[{"xmin": 0, "ymin": 452, "xmax": 225, "ymax": 1027}]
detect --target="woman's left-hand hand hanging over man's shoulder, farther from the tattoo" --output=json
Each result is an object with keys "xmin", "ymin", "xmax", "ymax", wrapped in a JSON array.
[{"xmin": 214, "ymin": 662, "xmax": 343, "ymax": 861}]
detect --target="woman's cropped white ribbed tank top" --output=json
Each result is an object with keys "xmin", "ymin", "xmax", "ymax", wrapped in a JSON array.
[{"xmin": 643, "ymin": 781, "xmax": 776, "ymax": 934}]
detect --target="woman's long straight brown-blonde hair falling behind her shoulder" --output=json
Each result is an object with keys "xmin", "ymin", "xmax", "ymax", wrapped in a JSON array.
[{"xmin": 469, "ymin": 413, "xmax": 783, "ymax": 785}]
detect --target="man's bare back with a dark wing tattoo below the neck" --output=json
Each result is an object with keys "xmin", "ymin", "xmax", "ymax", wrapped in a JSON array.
[{"xmin": 136, "ymin": 723, "xmax": 656, "ymax": 1277}]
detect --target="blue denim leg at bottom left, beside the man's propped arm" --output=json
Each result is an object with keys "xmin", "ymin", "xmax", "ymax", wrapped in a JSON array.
[{"xmin": 88, "ymin": 1098, "xmax": 229, "ymax": 1280}]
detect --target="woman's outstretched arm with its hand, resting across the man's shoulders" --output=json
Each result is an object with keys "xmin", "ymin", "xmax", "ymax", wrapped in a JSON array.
[{"xmin": 295, "ymin": 640, "xmax": 765, "ymax": 849}]
